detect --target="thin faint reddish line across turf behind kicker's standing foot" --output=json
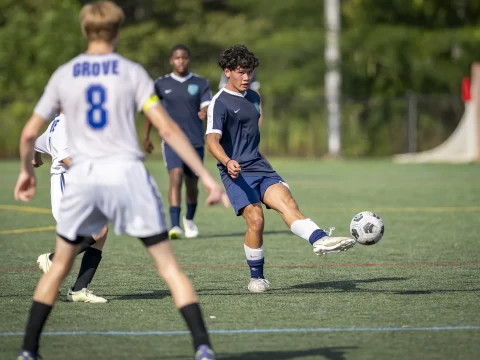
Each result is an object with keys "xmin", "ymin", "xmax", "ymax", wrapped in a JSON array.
[{"xmin": 0, "ymin": 263, "xmax": 480, "ymax": 271}]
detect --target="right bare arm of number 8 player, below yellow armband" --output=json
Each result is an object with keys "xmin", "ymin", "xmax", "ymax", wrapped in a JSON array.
[{"xmin": 144, "ymin": 105, "xmax": 230, "ymax": 207}]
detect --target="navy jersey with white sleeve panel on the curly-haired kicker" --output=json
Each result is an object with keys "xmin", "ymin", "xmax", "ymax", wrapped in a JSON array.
[{"xmin": 207, "ymin": 88, "xmax": 275, "ymax": 185}]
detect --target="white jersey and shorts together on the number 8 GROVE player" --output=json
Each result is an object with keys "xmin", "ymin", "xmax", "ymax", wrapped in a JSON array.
[{"xmin": 34, "ymin": 53, "xmax": 166, "ymax": 241}]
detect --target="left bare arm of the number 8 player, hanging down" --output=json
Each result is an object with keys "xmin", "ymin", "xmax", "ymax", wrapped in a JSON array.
[{"xmin": 14, "ymin": 114, "xmax": 45, "ymax": 202}]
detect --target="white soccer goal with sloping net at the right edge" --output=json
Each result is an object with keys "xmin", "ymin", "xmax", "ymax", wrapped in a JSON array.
[{"xmin": 393, "ymin": 63, "xmax": 480, "ymax": 164}]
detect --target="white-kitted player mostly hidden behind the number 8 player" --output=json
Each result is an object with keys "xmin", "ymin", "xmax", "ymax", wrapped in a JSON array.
[{"xmin": 33, "ymin": 114, "xmax": 108, "ymax": 304}]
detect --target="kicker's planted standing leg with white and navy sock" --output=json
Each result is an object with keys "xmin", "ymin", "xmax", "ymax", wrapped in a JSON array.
[{"xmin": 242, "ymin": 202, "xmax": 270, "ymax": 293}]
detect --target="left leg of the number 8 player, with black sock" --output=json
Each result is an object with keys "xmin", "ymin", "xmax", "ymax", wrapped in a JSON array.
[{"xmin": 18, "ymin": 236, "xmax": 78, "ymax": 360}]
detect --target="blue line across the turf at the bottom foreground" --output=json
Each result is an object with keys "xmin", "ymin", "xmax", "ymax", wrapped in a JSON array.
[{"xmin": 0, "ymin": 326, "xmax": 480, "ymax": 336}]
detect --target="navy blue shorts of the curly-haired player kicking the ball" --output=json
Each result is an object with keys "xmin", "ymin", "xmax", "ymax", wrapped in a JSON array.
[{"xmin": 226, "ymin": 173, "xmax": 288, "ymax": 216}]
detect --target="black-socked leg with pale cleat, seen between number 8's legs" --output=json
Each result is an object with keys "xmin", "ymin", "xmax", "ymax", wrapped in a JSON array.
[{"xmin": 67, "ymin": 226, "xmax": 108, "ymax": 304}]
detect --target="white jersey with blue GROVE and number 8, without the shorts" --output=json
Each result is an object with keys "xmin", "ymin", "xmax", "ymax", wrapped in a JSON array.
[{"xmin": 34, "ymin": 53, "xmax": 155, "ymax": 163}]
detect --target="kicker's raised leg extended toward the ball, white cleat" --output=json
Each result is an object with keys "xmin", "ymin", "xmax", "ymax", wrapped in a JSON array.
[{"xmin": 263, "ymin": 184, "xmax": 355, "ymax": 255}]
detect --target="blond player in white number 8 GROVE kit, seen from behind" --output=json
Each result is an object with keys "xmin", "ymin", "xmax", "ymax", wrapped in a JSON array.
[{"xmin": 15, "ymin": 1, "xmax": 229, "ymax": 360}]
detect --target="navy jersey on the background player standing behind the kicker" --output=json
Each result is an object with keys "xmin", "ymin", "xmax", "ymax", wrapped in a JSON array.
[{"xmin": 155, "ymin": 73, "xmax": 212, "ymax": 148}]
